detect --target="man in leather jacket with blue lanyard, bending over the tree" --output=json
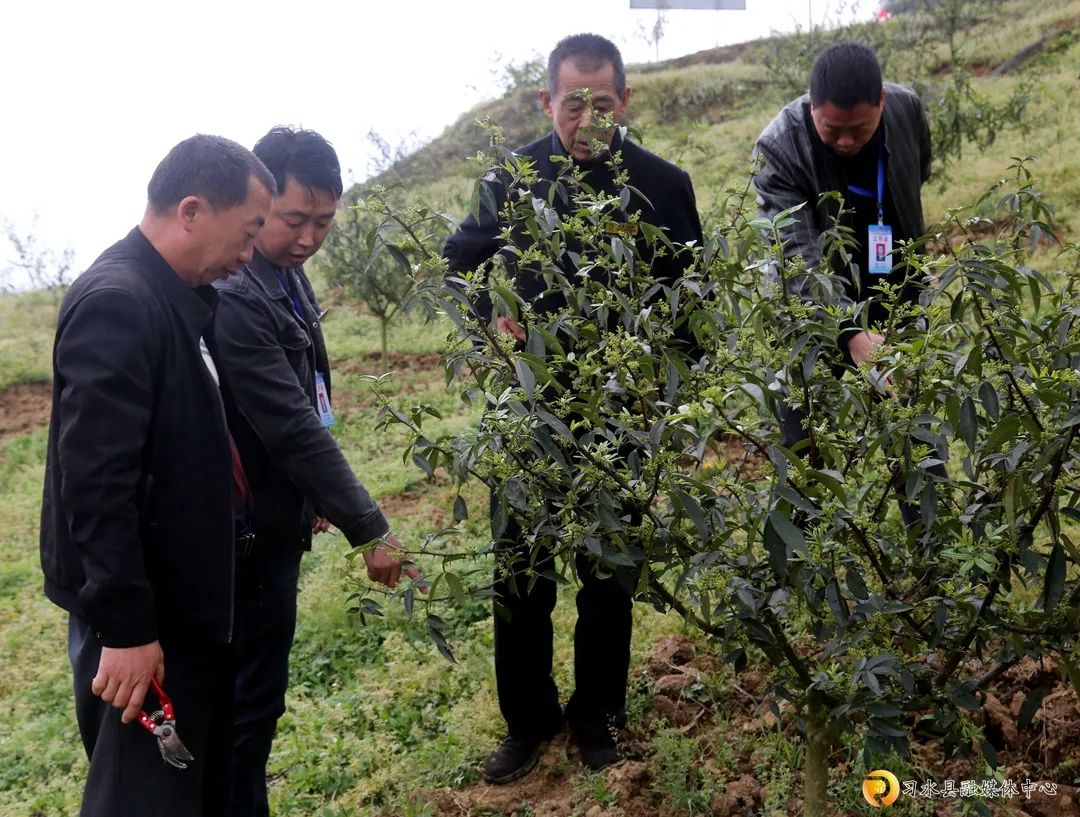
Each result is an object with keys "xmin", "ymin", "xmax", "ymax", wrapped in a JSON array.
[{"xmin": 754, "ymin": 42, "xmax": 944, "ymax": 524}]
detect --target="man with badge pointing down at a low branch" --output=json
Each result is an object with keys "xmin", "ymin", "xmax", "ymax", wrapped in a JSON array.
[{"xmin": 210, "ymin": 128, "xmax": 419, "ymax": 817}]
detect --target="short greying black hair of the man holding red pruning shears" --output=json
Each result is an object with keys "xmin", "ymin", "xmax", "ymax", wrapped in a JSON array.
[{"xmin": 146, "ymin": 133, "xmax": 274, "ymax": 214}]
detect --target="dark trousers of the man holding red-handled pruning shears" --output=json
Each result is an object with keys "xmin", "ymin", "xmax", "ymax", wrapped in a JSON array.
[{"xmin": 68, "ymin": 615, "xmax": 232, "ymax": 817}]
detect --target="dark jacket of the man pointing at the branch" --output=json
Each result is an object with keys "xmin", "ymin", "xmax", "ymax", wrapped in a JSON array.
[{"xmin": 216, "ymin": 253, "xmax": 389, "ymax": 550}]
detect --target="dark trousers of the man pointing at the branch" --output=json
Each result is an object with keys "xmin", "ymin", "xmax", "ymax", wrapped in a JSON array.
[{"xmin": 229, "ymin": 544, "xmax": 303, "ymax": 817}]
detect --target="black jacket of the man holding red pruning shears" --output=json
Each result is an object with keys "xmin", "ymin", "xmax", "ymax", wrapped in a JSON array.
[{"xmin": 41, "ymin": 228, "xmax": 233, "ymax": 647}]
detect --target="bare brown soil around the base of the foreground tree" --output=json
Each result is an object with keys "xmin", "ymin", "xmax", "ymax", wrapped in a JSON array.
[{"xmin": 412, "ymin": 637, "xmax": 1080, "ymax": 817}]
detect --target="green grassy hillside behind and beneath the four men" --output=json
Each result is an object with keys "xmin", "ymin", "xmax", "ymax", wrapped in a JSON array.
[{"xmin": 0, "ymin": 0, "xmax": 1080, "ymax": 817}]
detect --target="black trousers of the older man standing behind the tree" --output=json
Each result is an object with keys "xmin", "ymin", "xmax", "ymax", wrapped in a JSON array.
[{"xmin": 495, "ymin": 519, "xmax": 637, "ymax": 739}]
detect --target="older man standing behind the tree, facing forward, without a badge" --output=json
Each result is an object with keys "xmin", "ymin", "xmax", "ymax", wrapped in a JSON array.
[{"xmin": 444, "ymin": 35, "xmax": 702, "ymax": 783}]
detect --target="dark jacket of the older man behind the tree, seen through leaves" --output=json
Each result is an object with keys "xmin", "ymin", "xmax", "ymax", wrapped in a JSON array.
[{"xmin": 443, "ymin": 131, "xmax": 703, "ymax": 317}]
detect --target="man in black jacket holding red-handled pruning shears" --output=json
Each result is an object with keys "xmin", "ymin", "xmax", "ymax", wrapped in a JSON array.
[{"xmin": 41, "ymin": 135, "xmax": 273, "ymax": 817}]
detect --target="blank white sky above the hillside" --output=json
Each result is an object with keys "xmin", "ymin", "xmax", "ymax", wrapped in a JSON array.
[{"xmin": 0, "ymin": 0, "xmax": 878, "ymax": 269}]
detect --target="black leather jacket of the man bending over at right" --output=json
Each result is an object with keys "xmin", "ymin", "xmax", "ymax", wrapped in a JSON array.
[{"xmin": 754, "ymin": 83, "xmax": 930, "ymax": 307}]
